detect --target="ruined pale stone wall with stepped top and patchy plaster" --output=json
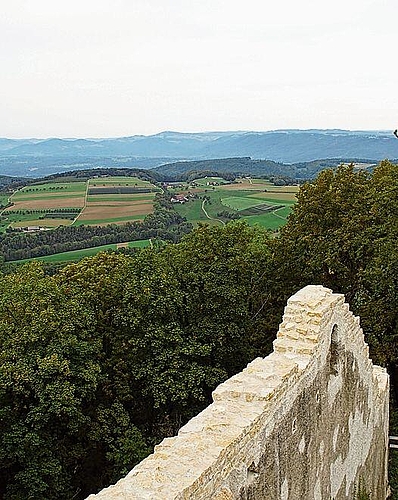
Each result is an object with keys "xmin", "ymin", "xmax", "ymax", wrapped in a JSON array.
[{"xmin": 89, "ymin": 286, "xmax": 389, "ymax": 500}]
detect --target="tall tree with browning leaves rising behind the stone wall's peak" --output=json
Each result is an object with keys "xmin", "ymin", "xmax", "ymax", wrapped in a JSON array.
[{"xmin": 274, "ymin": 161, "xmax": 398, "ymax": 396}]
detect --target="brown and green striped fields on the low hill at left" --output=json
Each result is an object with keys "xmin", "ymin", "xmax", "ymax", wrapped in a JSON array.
[{"xmin": 0, "ymin": 177, "xmax": 160, "ymax": 232}]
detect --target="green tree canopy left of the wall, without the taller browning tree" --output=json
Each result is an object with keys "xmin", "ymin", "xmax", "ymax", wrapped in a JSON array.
[{"xmin": 0, "ymin": 225, "xmax": 269, "ymax": 499}]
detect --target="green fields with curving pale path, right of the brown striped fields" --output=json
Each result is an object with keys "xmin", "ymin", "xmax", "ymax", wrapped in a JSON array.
[{"xmin": 169, "ymin": 177, "xmax": 298, "ymax": 230}]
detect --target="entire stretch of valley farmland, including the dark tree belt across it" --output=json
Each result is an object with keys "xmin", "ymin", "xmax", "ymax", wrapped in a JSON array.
[{"xmin": 0, "ymin": 175, "xmax": 298, "ymax": 262}]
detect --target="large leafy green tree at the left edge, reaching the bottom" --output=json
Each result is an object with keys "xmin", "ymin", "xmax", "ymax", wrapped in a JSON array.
[{"xmin": 0, "ymin": 264, "xmax": 99, "ymax": 499}]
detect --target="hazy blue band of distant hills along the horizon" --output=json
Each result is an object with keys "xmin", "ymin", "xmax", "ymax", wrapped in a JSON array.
[{"xmin": 0, "ymin": 129, "xmax": 398, "ymax": 177}]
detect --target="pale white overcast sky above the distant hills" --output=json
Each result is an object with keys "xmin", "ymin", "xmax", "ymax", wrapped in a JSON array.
[{"xmin": 0, "ymin": 0, "xmax": 398, "ymax": 138}]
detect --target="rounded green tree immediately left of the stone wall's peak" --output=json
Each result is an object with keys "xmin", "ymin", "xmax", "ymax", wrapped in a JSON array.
[{"xmin": 164, "ymin": 222, "xmax": 270, "ymax": 376}]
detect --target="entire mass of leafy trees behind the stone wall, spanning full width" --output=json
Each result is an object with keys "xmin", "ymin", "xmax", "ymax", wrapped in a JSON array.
[{"xmin": 0, "ymin": 161, "xmax": 398, "ymax": 499}]
